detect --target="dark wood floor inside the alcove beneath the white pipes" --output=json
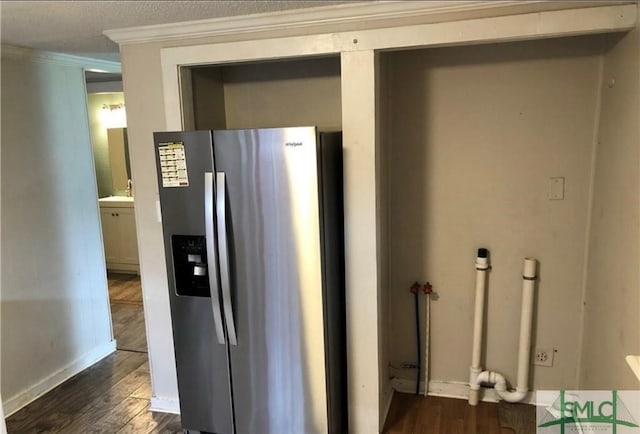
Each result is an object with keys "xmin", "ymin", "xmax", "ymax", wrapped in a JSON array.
[{"xmin": 383, "ymin": 393, "xmax": 535, "ymax": 434}]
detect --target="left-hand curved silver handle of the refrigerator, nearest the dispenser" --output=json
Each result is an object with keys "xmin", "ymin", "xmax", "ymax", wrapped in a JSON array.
[{"xmin": 204, "ymin": 172, "xmax": 226, "ymax": 345}]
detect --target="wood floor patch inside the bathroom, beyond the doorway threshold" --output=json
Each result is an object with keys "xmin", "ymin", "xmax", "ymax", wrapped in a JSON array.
[{"xmin": 107, "ymin": 272, "xmax": 147, "ymax": 353}]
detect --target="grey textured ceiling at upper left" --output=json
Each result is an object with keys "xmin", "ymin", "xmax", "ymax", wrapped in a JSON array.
[{"xmin": 0, "ymin": 0, "xmax": 342, "ymax": 61}]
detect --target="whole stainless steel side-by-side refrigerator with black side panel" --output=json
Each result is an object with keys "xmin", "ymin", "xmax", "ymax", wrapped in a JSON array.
[{"xmin": 154, "ymin": 127, "xmax": 347, "ymax": 434}]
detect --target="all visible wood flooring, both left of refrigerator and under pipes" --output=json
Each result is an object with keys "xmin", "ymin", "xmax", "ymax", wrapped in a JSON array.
[{"xmin": 7, "ymin": 273, "xmax": 535, "ymax": 434}]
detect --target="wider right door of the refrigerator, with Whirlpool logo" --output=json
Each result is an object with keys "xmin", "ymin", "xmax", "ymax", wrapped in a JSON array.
[{"xmin": 213, "ymin": 127, "xmax": 328, "ymax": 434}]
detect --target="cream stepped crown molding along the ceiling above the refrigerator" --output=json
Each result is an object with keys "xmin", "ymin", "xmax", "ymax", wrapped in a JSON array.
[{"xmin": 104, "ymin": 0, "xmax": 560, "ymax": 45}]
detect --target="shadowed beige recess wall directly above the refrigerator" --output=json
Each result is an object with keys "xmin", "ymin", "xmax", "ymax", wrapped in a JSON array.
[{"xmin": 192, "ymin": 57, "xmax": 342, "ymax": 131}]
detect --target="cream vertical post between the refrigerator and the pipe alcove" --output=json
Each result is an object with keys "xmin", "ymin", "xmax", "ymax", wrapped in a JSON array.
[{"xmin": 341, "ymin": 50, "xmax": 381, "ymax": 433}]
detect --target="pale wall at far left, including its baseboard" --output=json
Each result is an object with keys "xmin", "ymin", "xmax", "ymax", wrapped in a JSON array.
[{"xmin": 0, "ymin": 47, "xmax": 114, "ymax": 413}]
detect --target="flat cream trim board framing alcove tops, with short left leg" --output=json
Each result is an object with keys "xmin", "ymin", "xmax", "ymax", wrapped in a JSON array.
[{"xmin": 160, "ymin": 3, "xmax": 637, "ymax": 130}]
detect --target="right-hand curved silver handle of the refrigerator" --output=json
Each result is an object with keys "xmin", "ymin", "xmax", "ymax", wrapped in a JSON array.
[{"xmin": 216, "ymin": 172, "xmax": 238, "ymax": 345}]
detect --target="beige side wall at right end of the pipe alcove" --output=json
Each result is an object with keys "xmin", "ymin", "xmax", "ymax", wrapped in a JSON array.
[{"xmin": 580, "ymin": 22, "xmax": 640, "ymax": 390}]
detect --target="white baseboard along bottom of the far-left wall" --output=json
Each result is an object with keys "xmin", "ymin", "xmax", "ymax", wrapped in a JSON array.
[{"xmin": 2, "ymin": 340, "xmax": 116, "ymax": 417}]
